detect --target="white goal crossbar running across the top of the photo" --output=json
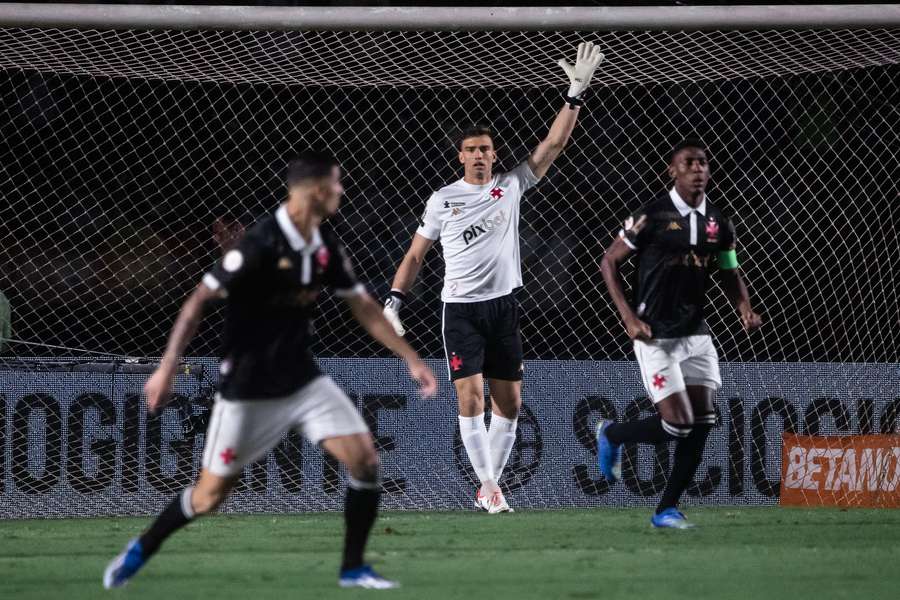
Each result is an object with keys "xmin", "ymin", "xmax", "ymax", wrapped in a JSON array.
[{"xmin": 0, "ymin": 3, "xmax": 900, "ymax": 31}]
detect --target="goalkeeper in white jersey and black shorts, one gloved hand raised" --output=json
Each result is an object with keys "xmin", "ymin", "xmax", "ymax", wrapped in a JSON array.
[{"xmin": 384, "ymin": 42, "xmax": 603, "ymax": 513}]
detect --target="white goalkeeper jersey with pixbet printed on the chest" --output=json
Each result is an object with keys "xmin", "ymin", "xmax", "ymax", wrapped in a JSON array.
[{"xmin": 416, "ymin": 161, "xmax": 538, "ymax": 302}]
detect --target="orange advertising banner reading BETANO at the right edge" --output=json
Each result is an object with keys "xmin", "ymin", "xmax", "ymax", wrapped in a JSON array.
[{"xmin": 779, "ymin": 433, "xmax": 900, "ymax": 508}]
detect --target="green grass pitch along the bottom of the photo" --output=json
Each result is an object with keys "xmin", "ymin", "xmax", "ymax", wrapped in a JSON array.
[{"xmin": 0, "ymin": 508, "xmax": 900, "ymax": 600}]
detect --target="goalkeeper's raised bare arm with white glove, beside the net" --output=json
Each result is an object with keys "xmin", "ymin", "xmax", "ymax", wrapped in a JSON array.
[{"xmin": 528, "ymin": 42, "xmax": 603, "ymax": 179}]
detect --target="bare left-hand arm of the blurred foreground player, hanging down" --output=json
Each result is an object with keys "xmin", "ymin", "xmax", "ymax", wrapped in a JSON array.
[{"xmin": 144, "ymin": 283, "xmax": 218, "ymax": 412}]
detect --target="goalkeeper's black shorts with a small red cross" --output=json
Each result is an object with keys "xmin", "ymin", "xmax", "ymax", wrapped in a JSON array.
[{"xmin": 442, "ymin": 294, "xmax": 522, "ymax": 381}]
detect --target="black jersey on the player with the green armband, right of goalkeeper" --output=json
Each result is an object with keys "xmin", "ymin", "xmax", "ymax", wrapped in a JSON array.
[{"xmin": 620, "ymin": 189, "xmax": 735, "ymax": 338}]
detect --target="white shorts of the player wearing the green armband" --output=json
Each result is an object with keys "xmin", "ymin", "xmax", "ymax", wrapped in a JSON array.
[{"xmin": 634, "ymin": 335, "xmax": 722, "ymax": 404}]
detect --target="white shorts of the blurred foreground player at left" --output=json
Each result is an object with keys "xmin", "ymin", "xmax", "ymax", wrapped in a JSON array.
[{"xmin": 203, "ymin": 376, "xmax": 369, "ymax": 477}]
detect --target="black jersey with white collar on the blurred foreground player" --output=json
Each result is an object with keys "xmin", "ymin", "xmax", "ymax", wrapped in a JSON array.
[{"xmin": 203, "ymin": 206, "xmax": 363, "ymax": 400}]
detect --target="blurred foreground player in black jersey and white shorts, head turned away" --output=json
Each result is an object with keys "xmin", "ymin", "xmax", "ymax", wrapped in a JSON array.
[{"xmin": 103, "ymin": 152, "xmax": 436, "ymax": 588}]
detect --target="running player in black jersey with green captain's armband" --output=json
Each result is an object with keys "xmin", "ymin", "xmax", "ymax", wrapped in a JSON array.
[{"xmin": 597, "ymin": 140, "xmax": 762, "ymax": 529}]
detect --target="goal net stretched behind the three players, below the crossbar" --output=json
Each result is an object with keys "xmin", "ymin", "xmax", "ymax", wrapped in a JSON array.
[{"xmin": 0, "ymin": 15, "xmax": 900, "ymax": 518}]
